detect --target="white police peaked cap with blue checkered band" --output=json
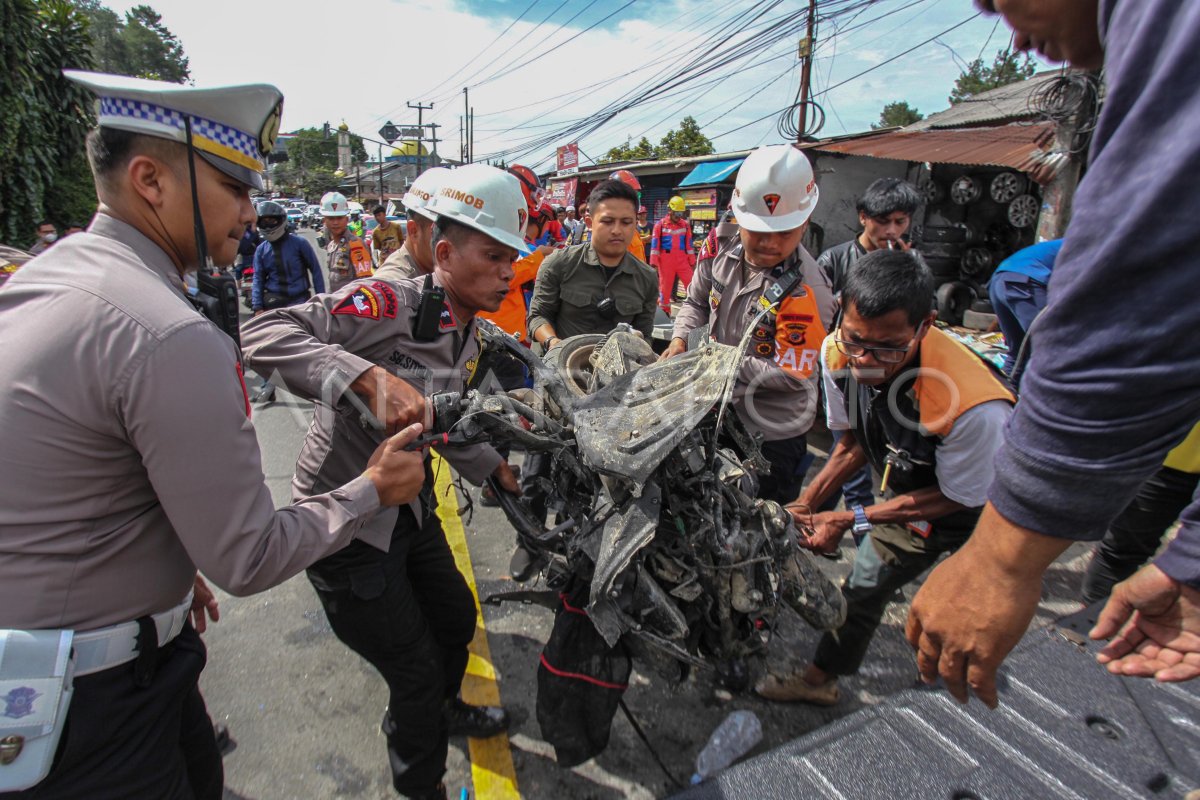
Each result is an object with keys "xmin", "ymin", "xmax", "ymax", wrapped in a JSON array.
[{"xmin": 62, "ymin": 70, "xmax": 283, "ymax": 190}]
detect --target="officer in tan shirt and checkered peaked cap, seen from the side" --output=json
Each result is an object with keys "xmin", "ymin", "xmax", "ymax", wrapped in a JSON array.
[{"xmin": 0, "ymin": 72, "xmax": 422, "ymax": 800}]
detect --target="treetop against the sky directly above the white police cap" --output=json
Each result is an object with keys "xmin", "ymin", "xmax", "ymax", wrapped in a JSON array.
[{"xmin": 76, "ymin": 0, "xmax": 191, "ymax": 83}]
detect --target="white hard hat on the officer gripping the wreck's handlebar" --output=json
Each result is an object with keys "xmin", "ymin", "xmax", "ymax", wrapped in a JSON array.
[{"xmin": 426, "ymin": 164, "xmax": 529, "ymax": 252}]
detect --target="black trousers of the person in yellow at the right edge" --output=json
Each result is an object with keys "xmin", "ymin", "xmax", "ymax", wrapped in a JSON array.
[{"xmin": 1084, "ymin": 467, "xmax": 1200, "ymax": 603}]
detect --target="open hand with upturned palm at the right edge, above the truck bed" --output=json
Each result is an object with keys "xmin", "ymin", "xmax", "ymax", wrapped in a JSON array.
[{"xmin": 1088, "ymin": 564, "xmax": 1200, "ymax": 681}]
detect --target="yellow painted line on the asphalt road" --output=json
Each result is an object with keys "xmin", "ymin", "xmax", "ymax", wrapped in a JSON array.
[{"xmin": 433, "ymin": 453, "xmax": 521, "ymax": 800}]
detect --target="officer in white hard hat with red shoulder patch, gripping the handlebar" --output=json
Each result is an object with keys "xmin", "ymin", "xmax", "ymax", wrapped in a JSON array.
[{"xmin": 244, "ymin": 164, "xmax": 527, "ymax": 799}]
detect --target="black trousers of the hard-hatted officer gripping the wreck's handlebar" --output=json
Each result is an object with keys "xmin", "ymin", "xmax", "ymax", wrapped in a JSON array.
[{"xmin": 308, "ymin": 501, "xmax": 475, "ymax": 794}]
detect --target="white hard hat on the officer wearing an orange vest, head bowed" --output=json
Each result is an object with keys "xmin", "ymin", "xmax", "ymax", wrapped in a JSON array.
[{"xmin": 731, "ymin": 144, "xmax": 820, "ymax": 234}]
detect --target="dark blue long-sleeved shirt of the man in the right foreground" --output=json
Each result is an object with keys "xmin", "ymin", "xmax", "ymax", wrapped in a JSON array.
[{"xmin": 990, "ymin": 0, "xmax": 1200, "ymax": 588}]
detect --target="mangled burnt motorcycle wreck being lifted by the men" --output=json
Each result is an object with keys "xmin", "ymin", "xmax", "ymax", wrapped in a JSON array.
[{"xmin": 438, "ymin": 324, "xmax": 846, "ymax": 765}]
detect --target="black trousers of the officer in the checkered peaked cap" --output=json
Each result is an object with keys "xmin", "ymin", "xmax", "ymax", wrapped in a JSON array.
[{"xmin": 7, "ymin": 622, "xmax": 224, "ymax": 800}]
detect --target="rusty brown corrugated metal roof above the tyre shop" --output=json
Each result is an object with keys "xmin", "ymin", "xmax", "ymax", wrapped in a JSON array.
[{"xmin": 805, "ymin": 122, "xmax": 1054, "ymax": 172}]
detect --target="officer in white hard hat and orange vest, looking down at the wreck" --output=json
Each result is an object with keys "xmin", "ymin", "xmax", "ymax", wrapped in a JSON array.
[{"xmin": 662, "ymin": 145, "xmax": 836, "ymax": 503}]
